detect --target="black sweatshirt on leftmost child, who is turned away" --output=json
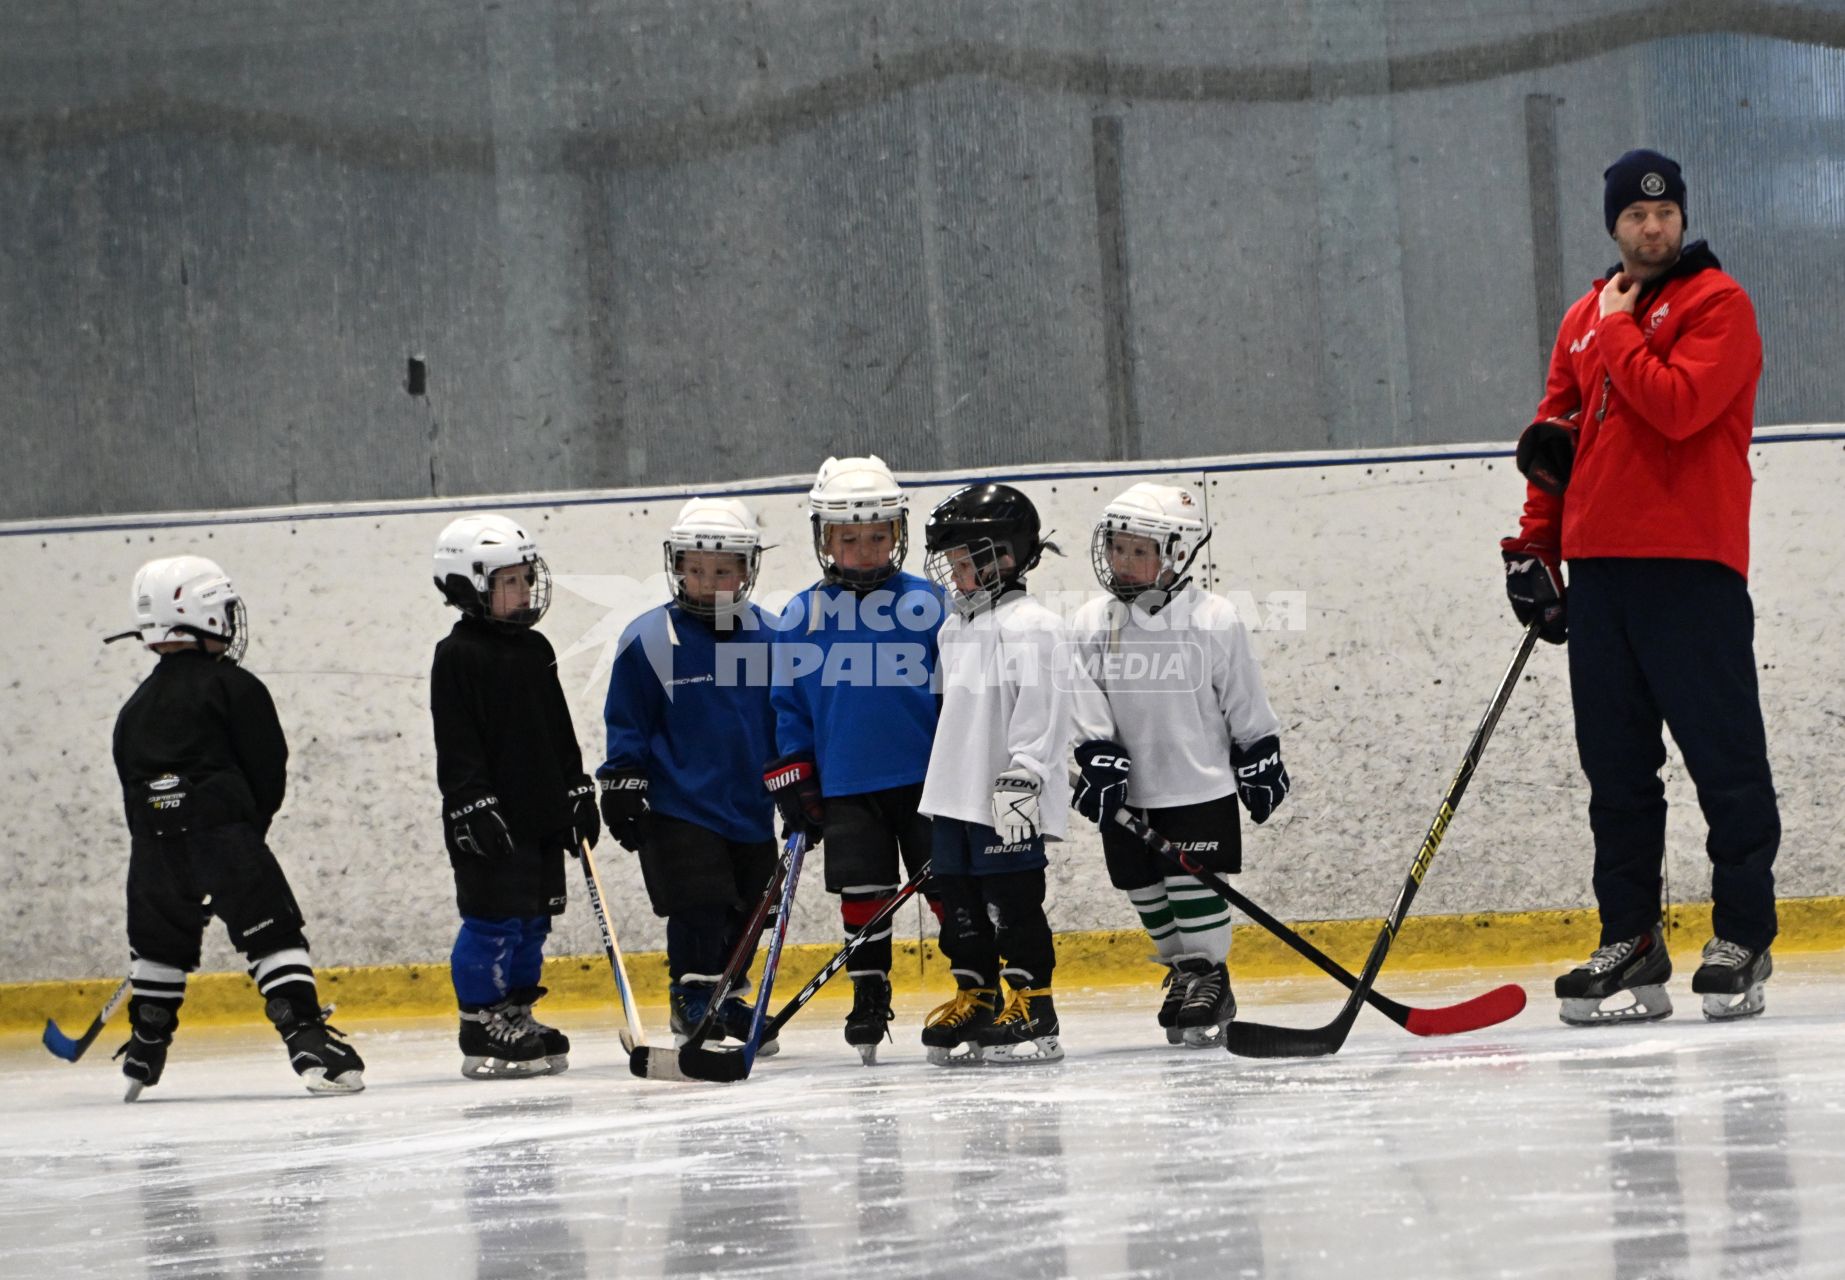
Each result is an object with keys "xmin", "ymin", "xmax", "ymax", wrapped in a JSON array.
[{"xmin": 114, "ymin": 649, "xmax": 288, "ymax": 834}]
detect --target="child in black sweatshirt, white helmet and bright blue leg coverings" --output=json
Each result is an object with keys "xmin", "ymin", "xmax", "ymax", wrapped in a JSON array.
[{"xmin": 430, "ymin": 515, "xmax": 601, "ymax": 1079}]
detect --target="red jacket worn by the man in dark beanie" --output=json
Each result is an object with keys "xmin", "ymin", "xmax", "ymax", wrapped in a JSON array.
[{"xmin": 1520, "ymin": 242, "xmax": 1762, "ymax": 577}]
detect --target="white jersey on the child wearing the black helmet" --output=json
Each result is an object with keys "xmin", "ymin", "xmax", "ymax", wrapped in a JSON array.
[{"xmin": 921, "ymin": 592, "xmax": 1070, "ymax": 839}]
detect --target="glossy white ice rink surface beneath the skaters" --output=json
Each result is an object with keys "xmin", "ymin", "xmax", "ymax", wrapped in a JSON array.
[{"xmin": 0, "ymin": 955, "xmax": 1845, "ymax": 1280}]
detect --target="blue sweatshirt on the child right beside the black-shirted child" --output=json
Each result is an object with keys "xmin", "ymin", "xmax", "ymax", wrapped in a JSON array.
[{"xmin": 598, "ymin": 605, "xmax": 775, "ymax": 841}]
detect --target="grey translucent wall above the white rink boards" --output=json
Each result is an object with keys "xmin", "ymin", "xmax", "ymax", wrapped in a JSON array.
[{"xmin": 0, "ymin": 0, "xmax": 1845, "ymax": 518}]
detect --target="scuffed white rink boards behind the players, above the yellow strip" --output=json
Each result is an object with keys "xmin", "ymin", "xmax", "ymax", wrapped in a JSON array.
[{"xmin": 0, "ymin": 437, "xmax": 1845, "ymax": 981}]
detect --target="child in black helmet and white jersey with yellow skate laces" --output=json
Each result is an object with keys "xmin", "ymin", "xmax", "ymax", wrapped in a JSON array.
[{"xmin": 921, "ymin": 485, "xmax": 1070, "ymax": 1064}]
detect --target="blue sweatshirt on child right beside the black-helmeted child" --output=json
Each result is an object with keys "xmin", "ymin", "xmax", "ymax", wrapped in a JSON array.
[{"xmin": 775, "ymin": 574, "xmax": 948, "ymax": 795}]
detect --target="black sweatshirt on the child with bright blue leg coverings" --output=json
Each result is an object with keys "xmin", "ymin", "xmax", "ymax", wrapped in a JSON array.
[{"xmin": 430, "ymin": 618, "xmax": 583, "ymax": 845}]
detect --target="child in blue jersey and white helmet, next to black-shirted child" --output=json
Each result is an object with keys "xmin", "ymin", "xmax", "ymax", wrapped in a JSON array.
[{"xmin": 596, "ymin": 498, "xmax": 777, "ymax": 1055}]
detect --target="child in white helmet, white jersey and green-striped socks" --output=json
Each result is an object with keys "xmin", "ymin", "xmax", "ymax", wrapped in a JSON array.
[{"xmin": 1070, "ymin": 483, "xmax": 1288, "ymax": 1048}]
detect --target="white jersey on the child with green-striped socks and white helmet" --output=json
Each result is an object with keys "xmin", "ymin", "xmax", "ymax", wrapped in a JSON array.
[{"xmin": 1070, "ymin": 587, "xmax": 1280, "ymax": 810}]
